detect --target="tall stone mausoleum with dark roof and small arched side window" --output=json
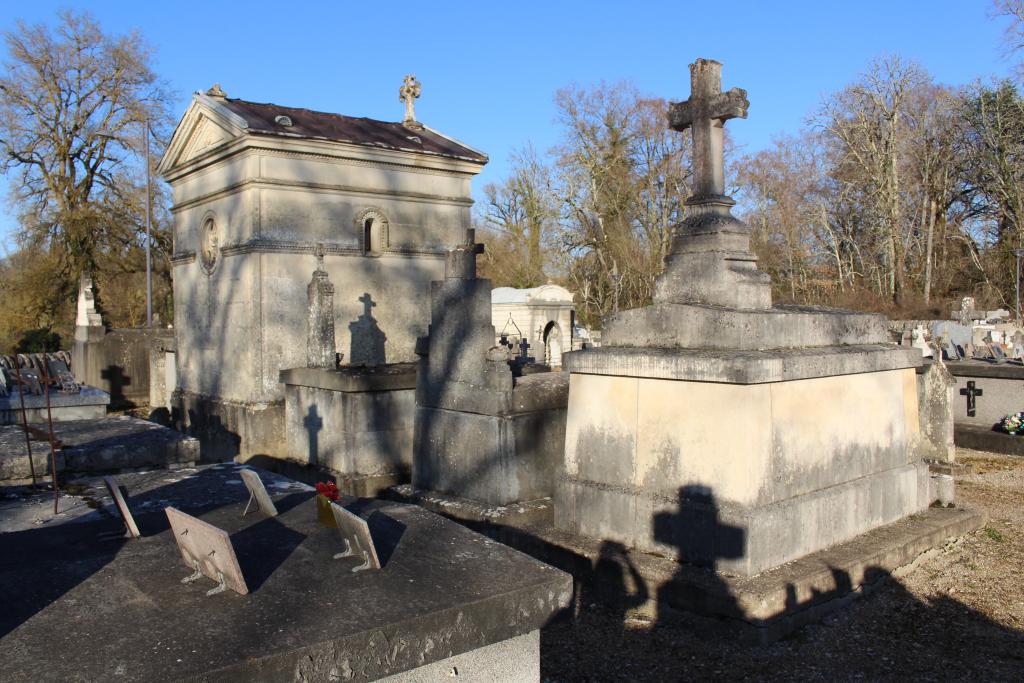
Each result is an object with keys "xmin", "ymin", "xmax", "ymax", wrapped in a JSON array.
[{"xmin": 159, "ymin": 79, "xmax": 487, "ymax": 459}]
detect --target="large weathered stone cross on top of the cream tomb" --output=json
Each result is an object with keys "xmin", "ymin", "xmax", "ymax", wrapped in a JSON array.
[{"xmin": 669, "ymin": 59, "xmax": 751, "ymax": 199}]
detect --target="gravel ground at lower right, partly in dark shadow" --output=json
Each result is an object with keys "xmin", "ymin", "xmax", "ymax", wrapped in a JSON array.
[{"xmin": 541, "ymin": 450, "xmax": 1024, "ymax": 682}]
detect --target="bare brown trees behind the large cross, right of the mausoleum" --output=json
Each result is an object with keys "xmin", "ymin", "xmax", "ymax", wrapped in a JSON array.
[{"xmin": 477, "ymin": 7, "xmax": 1024, "ymax": 327}]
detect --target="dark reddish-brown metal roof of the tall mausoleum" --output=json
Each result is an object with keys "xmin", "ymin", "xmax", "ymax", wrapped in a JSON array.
[{"xmin": 220, "ymin": 98, "xmax": 487, "ymax": 163}]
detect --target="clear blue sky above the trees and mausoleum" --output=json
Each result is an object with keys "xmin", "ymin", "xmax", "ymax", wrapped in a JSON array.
[{"xmin": 0, "ymin": 0, "xmax": 1011, "ymax": 254}]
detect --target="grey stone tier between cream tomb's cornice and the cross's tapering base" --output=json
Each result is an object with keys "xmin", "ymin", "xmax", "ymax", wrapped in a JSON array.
[{"xmin": 601, "ymin": 302, "xmax": 888, "ymax": 354}]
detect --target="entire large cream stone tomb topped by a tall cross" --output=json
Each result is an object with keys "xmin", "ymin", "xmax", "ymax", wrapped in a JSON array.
[{"xmin": 555, "ymin": 59, "xmax": 931, "ymax": 577}]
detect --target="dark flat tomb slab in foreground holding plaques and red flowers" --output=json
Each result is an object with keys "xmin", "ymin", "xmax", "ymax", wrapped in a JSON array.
[{"xmin": 0, "ymin": 465, "xmax": 571, "ymax": 681}]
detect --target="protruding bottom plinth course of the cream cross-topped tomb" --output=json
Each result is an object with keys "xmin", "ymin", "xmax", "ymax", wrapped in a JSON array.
[{"xmin": 556, "ymin": 463, "xmax": 931, "ymax": 577}]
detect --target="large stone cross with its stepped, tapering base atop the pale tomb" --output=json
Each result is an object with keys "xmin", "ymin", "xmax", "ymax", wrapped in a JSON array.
[{"xmin": 654, "ymin": 59, "xmax": 771, "ymax": 309}]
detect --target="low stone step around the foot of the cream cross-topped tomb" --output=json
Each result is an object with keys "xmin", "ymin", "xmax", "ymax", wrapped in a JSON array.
[{"xmin": 479, "ymin": 507, "xmax": 985, "ymax": 643}]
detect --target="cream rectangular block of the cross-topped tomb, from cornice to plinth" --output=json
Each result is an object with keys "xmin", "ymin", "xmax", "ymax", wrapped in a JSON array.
[{"xmin": 555, "ymin": 345, "xmax": 930, "ymax": 575}]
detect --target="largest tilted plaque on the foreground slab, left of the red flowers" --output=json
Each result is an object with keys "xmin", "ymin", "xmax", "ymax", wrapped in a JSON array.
[{"xmin": 166, "ymin": 507, "xmax": 249, "ymax": 595}]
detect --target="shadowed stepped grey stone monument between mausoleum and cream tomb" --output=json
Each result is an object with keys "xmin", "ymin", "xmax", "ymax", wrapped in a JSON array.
[{"xmin": 413, "ymin": 234, "xmax": 567, "ymax": 505}]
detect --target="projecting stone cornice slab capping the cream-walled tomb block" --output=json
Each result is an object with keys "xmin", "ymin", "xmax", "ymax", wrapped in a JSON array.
[{"xmin": 562, "ymin": 344, "xmax": 921, "ymax": 384}]
